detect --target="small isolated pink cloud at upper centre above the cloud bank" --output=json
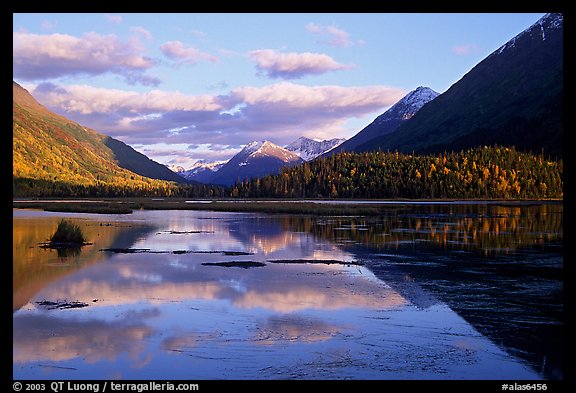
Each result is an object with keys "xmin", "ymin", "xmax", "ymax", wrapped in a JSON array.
[{"xmin": 249, "ymin": 49, "xmax": 352, "ymax": 79}]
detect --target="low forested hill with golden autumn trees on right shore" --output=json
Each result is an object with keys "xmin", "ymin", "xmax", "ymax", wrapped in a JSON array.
[{"xmin": 231, "ymin": 146, "xmax": 563, "ymax": 199}]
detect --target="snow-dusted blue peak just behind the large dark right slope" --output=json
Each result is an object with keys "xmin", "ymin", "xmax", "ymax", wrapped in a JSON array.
[{"xmin": 330, "ymin": 86, "xmax": 440, "ymax": 154}]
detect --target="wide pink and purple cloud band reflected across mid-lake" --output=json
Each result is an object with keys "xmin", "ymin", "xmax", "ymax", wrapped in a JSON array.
[{"xmin": 21, "ymin": 255, "xmax": 406, "ymax": 313}]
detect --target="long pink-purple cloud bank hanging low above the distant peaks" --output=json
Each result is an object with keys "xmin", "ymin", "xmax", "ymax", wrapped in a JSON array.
[{"xmin": 31, "ymin": 82, "xmax": 405, "ymax": 152}]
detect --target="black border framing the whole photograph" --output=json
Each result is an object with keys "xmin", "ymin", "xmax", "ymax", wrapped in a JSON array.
[{"xmin": 6, "ymin": 0, "xmax": 576, "ymax": 392}]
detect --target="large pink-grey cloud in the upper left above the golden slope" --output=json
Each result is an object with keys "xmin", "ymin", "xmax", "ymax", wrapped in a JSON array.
[{"xmin": 12, "ymin": 32, "xmax": 160, "ymax": 85}]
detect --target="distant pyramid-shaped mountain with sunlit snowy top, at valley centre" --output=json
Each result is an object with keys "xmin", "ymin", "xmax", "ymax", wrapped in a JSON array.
[{"xmin": 210, "ymin": 141, "xmax": 304, "ymax": 186}]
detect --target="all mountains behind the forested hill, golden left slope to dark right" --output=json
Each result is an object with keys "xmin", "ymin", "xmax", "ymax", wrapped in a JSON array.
[{"xmin": 13, "ymin": 14, "xmax": 563, "ymax": 194}]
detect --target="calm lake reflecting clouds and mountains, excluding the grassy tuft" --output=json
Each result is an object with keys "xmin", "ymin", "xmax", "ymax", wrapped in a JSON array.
[{"xmin": 13, "ymin": 202, "xmax": 563, "ymax": 380}]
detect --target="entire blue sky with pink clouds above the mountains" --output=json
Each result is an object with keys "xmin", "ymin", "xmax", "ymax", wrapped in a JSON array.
[{"xmin": 13, "ymin": 13, "xmax": 544, "ymax": 168}]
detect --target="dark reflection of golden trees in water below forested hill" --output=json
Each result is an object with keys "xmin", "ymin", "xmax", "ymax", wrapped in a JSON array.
[{"xmin": 285, "ymin": 204, "xmax": 563, "ymax": 256}]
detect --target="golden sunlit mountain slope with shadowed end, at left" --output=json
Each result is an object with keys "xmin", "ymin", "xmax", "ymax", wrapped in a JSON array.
[{"xmin": 12, "ymin": 82, "xmax": 184, "ymax": 186}]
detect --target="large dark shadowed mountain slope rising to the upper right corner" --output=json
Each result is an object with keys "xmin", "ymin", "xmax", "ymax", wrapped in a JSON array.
[{"xmin": 357, "ymin": 14, "xmax": 564, "ymax": 157}]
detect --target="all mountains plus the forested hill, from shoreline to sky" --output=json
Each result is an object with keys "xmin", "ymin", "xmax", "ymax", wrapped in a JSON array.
[{"xmin": 13, "ymin": 14, "xmax": 563, "ymax": 199}]
